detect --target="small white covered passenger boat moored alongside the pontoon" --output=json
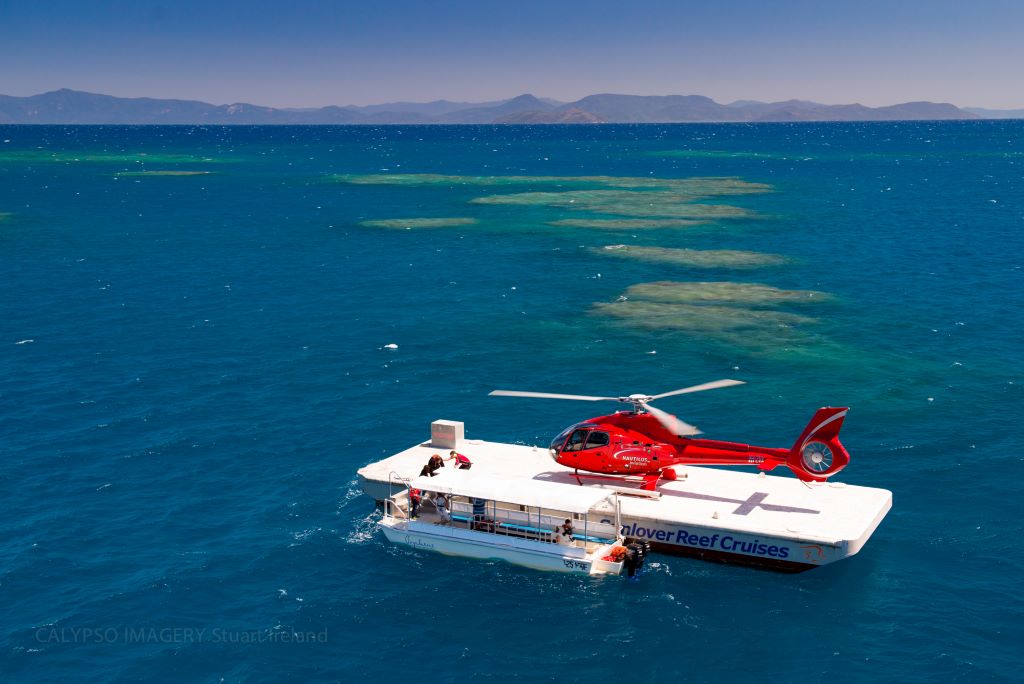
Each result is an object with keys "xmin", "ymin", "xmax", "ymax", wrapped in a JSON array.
[{"xmin": 380, "ymin": 469, "xmax": 634, "ymax": 574}]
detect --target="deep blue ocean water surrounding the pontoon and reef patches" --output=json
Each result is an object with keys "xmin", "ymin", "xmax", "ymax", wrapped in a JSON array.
[{"xmin": 0, "ymin": 122, "xmax": 1024, "ymax": 682}]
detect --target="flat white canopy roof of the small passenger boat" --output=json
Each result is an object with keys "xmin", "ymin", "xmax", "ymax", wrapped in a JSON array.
[{"xmin": 410, "ymin": 468, "xmax": 612, "ymax": 513}]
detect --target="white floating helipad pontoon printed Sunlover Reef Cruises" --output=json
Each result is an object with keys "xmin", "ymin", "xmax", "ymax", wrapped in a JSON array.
[{"xmin": 358, "ymin": 430, "xmax": 892, "ymax": 571}]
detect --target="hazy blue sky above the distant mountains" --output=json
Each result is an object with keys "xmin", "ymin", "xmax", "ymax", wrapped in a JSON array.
[{"xmin": 0, "ymin": 0, "xmax": 1024, "ymax": 108}]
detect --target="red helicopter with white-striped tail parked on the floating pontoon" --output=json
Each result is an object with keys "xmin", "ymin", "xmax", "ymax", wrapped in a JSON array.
[{"xmin": 490, "ymin": 380, "xmax": 850, "ymax": 489}]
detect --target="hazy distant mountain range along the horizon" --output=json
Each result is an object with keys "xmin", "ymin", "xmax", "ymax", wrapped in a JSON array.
[{"xmin": 0, "ymin": 89, "xmax": 1024, "ymax": 125}]
